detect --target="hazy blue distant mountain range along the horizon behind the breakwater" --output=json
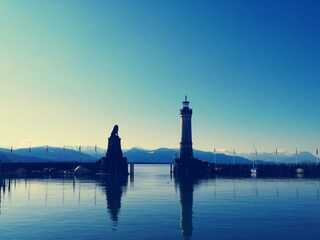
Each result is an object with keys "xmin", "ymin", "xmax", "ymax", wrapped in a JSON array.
[{"xmin": 0, "ymin": 146, "xmax": 317, "ymax": 163}]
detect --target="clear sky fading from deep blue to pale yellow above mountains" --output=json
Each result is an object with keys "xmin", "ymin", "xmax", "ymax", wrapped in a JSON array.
[{"xmin": 0, "ymin": 0, "xmax": 320, "ymax": 152}]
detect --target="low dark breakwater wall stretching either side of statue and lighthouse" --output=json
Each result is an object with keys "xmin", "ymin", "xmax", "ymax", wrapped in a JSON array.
[{"xmin": 0, "ymin": 161, "xmax": 320, "ymax": 177}]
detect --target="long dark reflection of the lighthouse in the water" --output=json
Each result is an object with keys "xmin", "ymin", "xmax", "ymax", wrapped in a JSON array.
[{"xmin": 175, "ymin": 176, "xmax": 199, "ymax": 239}]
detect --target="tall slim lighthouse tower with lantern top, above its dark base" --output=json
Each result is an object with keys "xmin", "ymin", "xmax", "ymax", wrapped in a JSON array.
[{"xmin": 180, "ymin": 96, "xmax": 193, "ymax": 162}]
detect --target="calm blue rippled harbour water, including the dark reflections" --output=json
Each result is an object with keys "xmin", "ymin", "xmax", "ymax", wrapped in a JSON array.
[{"xmin": 0, "ymin": 165, "xmax": 320, "ymax": 240}]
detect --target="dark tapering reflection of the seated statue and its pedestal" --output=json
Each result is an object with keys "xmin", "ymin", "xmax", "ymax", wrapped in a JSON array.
[{"xmin": 100, "ymin": 173, "xmax": 128, "ymax": 227}]
